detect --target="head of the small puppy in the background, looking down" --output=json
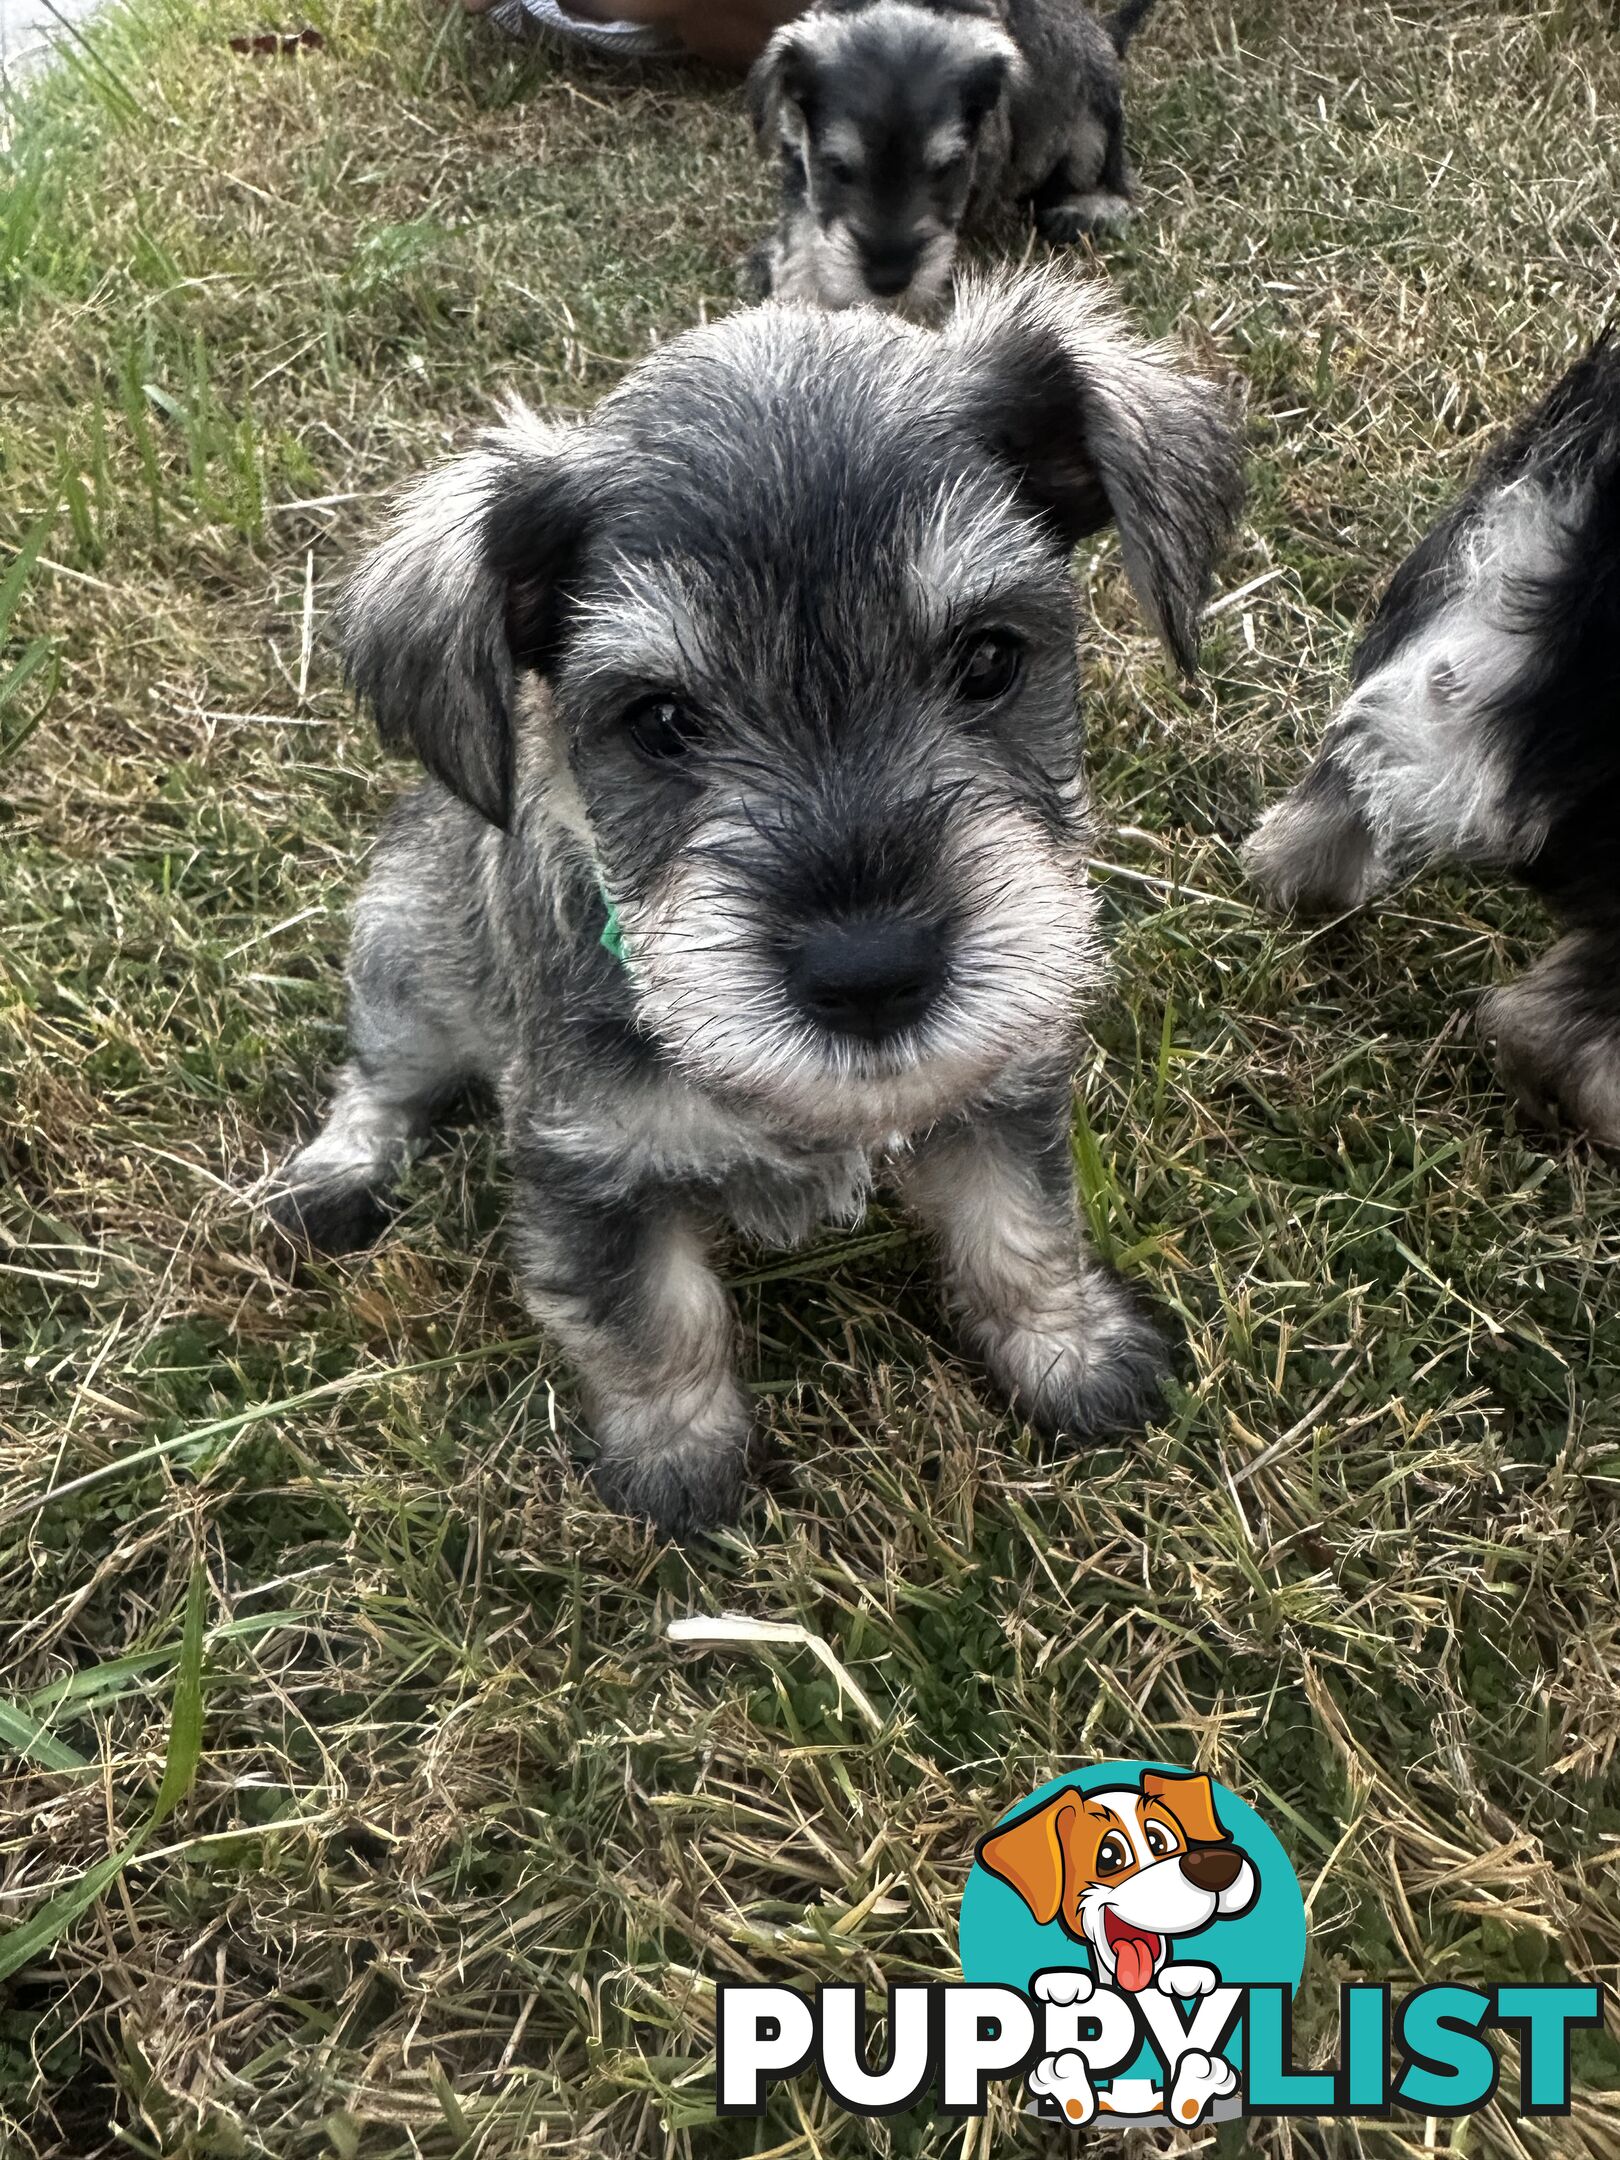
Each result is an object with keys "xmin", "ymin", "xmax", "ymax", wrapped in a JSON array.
[{"xmin": 750, "ymin": 0, "xmax": 1017, "ymax": 313}]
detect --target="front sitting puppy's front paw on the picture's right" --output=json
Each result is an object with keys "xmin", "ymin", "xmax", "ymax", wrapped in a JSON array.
[{"xmin": 981, "ymin": 1272, "xmax": 1171, "ymax": 1441}]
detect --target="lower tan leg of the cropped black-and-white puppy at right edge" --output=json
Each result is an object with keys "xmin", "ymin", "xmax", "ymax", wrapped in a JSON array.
[{"xmin": 1480, "ymin": 924, "xmax": 1620, "ymax": 1149}]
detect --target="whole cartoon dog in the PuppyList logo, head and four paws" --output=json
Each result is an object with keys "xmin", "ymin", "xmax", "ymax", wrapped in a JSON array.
[{"xmin": 978, "ymin": 1771, "xmax": 1259, "ymax": 2128}]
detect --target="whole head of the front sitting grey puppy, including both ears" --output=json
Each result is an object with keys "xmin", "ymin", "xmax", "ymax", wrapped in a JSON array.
[{"xmin": 348, "ymin": 283, "xmax": 1236, "ymax": 1143}]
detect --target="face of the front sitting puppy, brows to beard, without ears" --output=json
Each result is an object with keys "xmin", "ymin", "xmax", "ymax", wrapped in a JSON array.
[{"xmin": 555, "ymin": 447, "xmax": 1095, "ymax": 1138}]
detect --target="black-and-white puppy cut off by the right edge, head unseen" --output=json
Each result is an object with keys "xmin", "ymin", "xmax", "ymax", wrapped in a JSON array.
[{"xmin": 1246, "ymin": 337, "xmax": 1620, "ymax": 1147}]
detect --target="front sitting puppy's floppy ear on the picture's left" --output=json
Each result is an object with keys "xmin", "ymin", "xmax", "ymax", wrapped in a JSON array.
[{"xmin": 339, "ymin": 406, "xmax": 583, "ymax": 825}]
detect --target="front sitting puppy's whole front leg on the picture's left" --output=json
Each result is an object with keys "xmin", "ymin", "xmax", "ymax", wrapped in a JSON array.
[{"xmin": 512, "ymin": 1158, "xmax": 752, "ymax": 1538}]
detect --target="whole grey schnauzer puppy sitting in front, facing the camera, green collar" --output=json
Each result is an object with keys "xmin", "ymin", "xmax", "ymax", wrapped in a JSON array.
[{"xmin": 272, "ymin": 279, "xmax": 1240, "ymax": 1531}]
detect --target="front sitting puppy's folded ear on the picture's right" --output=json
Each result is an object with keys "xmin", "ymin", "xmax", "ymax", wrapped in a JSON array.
[{"xmin": 944, "ymin": 274, "xmax": 1244, "ymax": 674}]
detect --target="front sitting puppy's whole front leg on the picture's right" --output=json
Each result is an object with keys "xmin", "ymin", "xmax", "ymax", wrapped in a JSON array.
[{"xmin": 903, "ymin": 1097, "xmax": 1166, "ymax": 1439}]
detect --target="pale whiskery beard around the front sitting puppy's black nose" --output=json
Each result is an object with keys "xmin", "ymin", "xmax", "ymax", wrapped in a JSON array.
[{"xmin": 622, "ymin": 810, "xmax": 1102, "ymax": 1145}]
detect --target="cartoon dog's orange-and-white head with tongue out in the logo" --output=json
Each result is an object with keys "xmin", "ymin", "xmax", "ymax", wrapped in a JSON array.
[{"xmin": 978, "ymin": 1771, "xmax": 1259, "ymax": 1994}]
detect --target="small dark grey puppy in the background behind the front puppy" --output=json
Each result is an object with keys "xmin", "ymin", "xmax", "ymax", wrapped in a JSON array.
[{"xmin": 747, "ymin": 0, "xmax": 1153, "ymax": 315}]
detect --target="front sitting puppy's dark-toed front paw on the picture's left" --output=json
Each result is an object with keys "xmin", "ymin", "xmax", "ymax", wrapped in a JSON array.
[{"xmin": 594, "ymin": 1389, "xmax": 752, "ymax": 1542}]
